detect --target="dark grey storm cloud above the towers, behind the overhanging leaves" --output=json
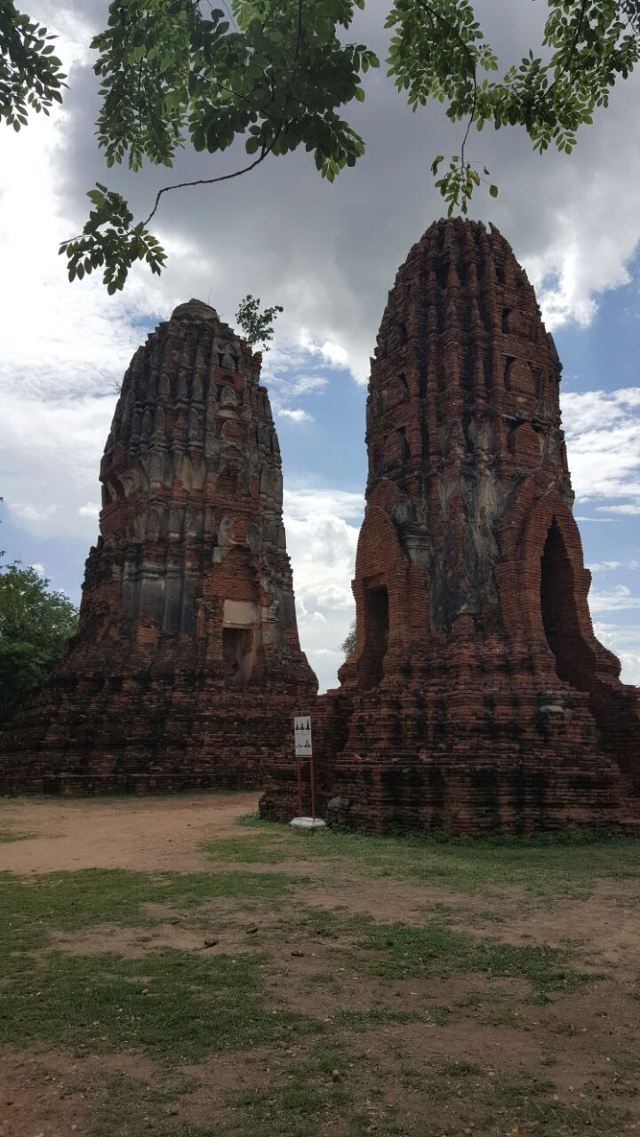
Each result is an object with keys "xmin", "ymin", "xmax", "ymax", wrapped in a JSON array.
[{"xmin": 48, "ymin": 0, "xmax": 640, "ymax": 377}]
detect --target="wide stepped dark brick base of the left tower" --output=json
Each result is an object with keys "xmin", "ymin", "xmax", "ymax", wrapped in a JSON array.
[{"xmin": 0, "ymin": 682, "xmax": 311, "ymax": 796}]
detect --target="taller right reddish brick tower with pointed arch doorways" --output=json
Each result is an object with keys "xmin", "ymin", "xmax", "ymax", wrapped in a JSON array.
[{"xmin": 263, "ymin": 221, "xmax": 640, "ymax": 833}]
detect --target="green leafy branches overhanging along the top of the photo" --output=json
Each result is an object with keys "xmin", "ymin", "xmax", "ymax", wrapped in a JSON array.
[{"xmin": 0, "ymin": 0, "xmax": 640, "ymax": 292}]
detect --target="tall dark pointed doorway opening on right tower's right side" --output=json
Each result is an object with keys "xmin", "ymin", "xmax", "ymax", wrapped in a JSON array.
[{"xmin": 540, "ymin": 518, "xmax": 596, "ymax": 690}]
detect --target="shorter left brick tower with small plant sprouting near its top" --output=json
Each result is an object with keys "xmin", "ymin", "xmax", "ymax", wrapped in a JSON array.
[{"xmin": 0, "ymin": 300, "xmax": 317, "ymax": 794}]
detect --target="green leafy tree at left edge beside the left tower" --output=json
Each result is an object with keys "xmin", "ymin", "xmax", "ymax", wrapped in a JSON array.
[{"xmin": 0, "ymin": 553, "xmax": 77, "ymax": 720}]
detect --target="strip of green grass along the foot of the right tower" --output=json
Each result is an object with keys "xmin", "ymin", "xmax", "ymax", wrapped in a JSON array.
[{"xmin": 200, "ymin": 815, "xmax": 640, "ymax": 897}]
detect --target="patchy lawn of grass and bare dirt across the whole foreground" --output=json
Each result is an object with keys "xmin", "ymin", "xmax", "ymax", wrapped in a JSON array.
[{"xmin": 0, "ymin": 802, "xmax": 640, "ymax": 1137}]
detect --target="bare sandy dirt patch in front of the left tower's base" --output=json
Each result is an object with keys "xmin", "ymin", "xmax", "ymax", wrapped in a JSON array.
[{"xmin": 0, "ymin": 792, "xmax": 258, "ymax": 873}]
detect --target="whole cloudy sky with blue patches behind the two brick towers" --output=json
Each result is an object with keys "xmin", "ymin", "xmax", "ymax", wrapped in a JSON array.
[{"xmin": 0, "ymin": 0, "xmax": 640, "ymax": 688}]
